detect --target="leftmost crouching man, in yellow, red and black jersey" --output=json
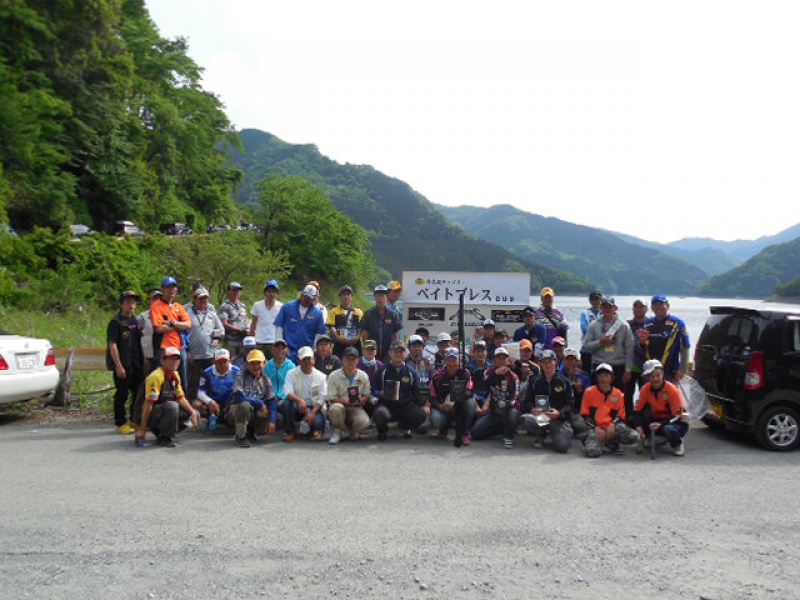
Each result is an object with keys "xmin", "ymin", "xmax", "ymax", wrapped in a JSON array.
[{"xmin": 136, "ymin": 346, "xmax": 198, "ymax": 448}]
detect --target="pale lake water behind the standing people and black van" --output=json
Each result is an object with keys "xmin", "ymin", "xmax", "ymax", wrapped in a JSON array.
[{"xmin": 544, "ymin": 296, "xmax": 800, "ymax": 356}]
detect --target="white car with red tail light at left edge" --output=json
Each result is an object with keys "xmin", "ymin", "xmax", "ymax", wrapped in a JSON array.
[{"xmin": 0, "ymin": 330, "xmax": 59, "ymax": 404}]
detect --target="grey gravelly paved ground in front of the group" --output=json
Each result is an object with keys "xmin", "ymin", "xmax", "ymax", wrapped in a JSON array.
[{"xmin": 0, "ymin": 422, "xmax": 800, "ymax": 600}]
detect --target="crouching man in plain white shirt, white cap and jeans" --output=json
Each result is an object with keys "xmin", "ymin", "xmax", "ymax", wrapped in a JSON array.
[{"xmin": 280, "ymin": 346, "xmax": 328, "ymax": 442}]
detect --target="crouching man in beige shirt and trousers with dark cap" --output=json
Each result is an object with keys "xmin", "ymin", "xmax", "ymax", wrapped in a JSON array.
[{"xmin": 328, "ymin": 346, "xmax": 372, "ymax": 445}]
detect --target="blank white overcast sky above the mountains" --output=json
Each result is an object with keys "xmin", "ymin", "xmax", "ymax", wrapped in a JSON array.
[{"xmin": 147, "ymin": 0, "xmax": 800, "ymax": 242}]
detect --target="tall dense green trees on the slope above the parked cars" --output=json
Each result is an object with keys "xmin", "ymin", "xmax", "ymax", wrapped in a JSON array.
[{"xmin": 0, "ymin": 0, "xmax": 240, "ymax": 231}]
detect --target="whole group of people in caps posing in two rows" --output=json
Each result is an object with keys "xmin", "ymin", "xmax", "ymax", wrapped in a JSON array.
[{"xmin": 107, "ymin": 277, "xmax": 689, "ymax": 457}]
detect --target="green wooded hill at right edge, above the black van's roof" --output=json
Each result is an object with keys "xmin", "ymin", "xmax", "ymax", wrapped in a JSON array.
[{"xmin": 698, "ymin": 238, "xmax": 800, "ymax": 298}]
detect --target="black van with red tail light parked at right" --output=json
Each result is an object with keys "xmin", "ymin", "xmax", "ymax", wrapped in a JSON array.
[{"xmin": 694, "ymin": 306, "xmax": 800, "ymax": 451}]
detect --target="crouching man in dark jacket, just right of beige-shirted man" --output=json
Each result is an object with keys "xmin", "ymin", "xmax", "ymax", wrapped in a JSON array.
[{"xmin": 372, "ymin": 342, "xmax": 428, "ymax": 441}]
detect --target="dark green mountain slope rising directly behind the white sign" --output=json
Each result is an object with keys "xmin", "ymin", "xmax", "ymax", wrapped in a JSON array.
[{"xmin": 231, "ymin": 129, "xmax": 592, "ymax": 292}]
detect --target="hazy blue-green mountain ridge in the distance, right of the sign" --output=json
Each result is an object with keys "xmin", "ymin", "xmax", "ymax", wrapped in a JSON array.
[{"xmin": 437, "ymin": 204, "xmax": 708, "ymax": 294}]
